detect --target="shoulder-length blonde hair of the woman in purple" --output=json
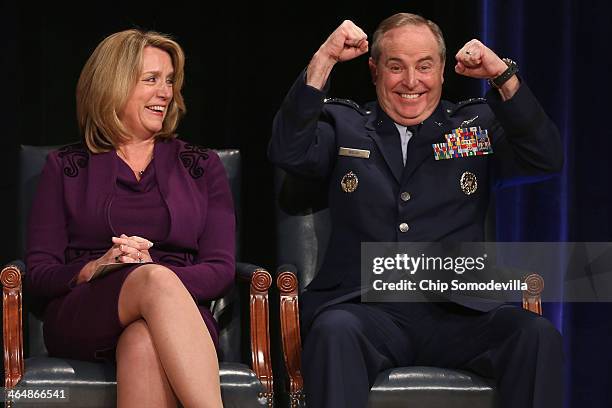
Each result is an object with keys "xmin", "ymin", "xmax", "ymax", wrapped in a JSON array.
[{"xmin": 76, "ymin": 29, "xmax": 186, "ymax": 153}]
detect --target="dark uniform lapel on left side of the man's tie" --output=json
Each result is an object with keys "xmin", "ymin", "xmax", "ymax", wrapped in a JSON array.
[{"xmin": 366, "ymin": 104, "xmax": 404, "ymax": 183}]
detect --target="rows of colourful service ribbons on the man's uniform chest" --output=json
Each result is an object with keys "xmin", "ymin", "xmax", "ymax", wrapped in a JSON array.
[{"xmin": 431, "ymin": 126, "xmax": 493, "ymax": 160}]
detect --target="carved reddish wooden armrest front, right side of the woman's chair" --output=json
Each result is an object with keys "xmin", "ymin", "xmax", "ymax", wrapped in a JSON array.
[{"xmin": 250, "ymin": 268, "xmax": 274, "ymax": 406}]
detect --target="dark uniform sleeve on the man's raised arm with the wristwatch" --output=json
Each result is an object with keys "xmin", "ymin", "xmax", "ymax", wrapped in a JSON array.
[{"xmin": 487, "ymin": 82, "xmax": 563, "ymax": 186}]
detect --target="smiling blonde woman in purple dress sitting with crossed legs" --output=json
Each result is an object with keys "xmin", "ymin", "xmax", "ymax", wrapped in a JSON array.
[{"xmin": 26, "ymin": 30, "xmax": 235, "ymax": 407}]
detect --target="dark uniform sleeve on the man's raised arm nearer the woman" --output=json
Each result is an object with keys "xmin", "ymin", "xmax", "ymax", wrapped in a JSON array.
[{"xmin": 268, "ymin": 72, "xmax": 336, "ymax": 178}]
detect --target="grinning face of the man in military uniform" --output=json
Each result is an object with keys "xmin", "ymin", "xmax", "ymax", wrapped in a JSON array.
[{"xmin": 369, "ymin": 25, "xmax": 444, "ymax": 126}]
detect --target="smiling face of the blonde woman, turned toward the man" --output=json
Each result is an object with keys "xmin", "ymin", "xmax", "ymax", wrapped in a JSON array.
[{"xmin": 119, "ymin": 46, "xmax": 174, "ymax": 140}]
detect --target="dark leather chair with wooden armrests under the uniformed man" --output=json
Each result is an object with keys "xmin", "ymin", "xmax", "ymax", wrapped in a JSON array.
[{"xmin": 275, "ymin": 170, "xmax": 543, "ymax": 408}]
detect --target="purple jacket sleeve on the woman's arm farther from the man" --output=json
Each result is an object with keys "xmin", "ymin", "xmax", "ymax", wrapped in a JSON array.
[{"xmin": 26, "ymin": 153, "xmax": 86, "ymax": 298}]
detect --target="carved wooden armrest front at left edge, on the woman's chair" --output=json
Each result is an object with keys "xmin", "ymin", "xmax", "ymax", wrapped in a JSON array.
[{"xmin": 0, "ymin": 264, "xmax": 24, "ymax": 388}]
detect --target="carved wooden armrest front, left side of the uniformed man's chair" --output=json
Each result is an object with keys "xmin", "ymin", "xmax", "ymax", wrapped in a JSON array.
[{"xmin": 276, "ymin": 267, "xmax": 304, "ymax": 407}]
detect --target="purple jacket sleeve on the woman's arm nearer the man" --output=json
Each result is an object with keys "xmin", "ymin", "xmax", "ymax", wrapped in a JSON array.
[{"xmin": 168, "ymin": 152, "xmax": 236, "ymax": 302}]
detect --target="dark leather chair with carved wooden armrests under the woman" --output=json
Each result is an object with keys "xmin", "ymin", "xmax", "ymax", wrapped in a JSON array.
[{"xmin": 0, "ymin": 146, "xmax": 274, "ymax": 407}]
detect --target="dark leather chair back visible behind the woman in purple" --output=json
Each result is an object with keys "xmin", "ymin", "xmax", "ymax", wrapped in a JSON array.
[{"xmin": 18, "ymin": 146, "xmax": 242, "ymax": 362}]
